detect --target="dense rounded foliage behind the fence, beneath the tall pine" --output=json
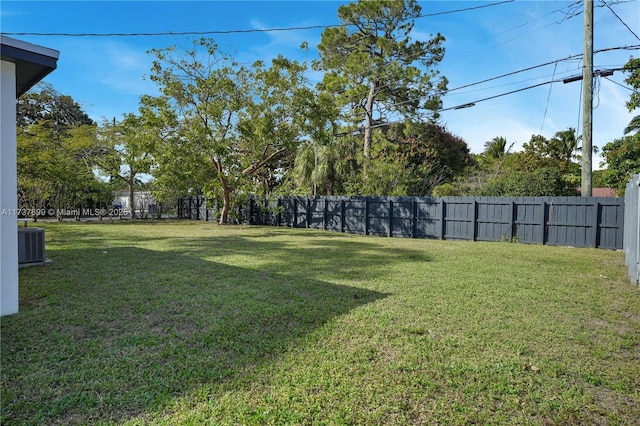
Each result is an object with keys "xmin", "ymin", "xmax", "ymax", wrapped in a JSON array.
[{"xmin": 294, "ymin": 121, "xmax": 473, "ymax": 195}]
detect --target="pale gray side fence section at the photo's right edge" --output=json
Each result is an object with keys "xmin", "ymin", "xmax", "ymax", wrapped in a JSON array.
[{"xmin": 623, "ymin": 175, "xmax": 640, "ymax": 285}]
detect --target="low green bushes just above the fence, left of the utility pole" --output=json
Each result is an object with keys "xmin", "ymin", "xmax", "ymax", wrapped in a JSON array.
[{"xmin": 478, "ymin": 167, "xmax": 576, "ymax": 197}]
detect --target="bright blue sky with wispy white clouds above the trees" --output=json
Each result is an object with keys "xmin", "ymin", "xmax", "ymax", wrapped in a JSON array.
[{"xmin": 0, "ymin": 0, "xmax": 640, "ymax": 168}]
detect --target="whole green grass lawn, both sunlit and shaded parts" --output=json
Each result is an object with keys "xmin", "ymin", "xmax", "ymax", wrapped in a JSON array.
[{"xmin": 0, "ymin": 221, "xmax": 640, "ymax": 425}]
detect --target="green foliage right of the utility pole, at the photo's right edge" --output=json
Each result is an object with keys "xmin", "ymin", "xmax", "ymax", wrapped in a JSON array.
[{"xmin": 602, "ymin": 132, "xmax": 640, "ymax": 196}]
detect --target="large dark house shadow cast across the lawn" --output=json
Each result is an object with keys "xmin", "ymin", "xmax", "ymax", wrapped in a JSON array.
[{"xmin": 0, "ymin": 246, "xmax": 386, "ymax": 425}]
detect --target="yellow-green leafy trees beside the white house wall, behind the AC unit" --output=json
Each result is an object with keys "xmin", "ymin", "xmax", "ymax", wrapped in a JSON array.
[{"xmin": 17, "ymin": 85, "xmax": 113, "ymax": 220}]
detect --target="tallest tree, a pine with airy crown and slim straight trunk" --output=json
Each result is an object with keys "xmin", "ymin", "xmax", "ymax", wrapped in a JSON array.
[{"xmin": 314, "ymin": 0, "xmax": 447, "ymax": 161}]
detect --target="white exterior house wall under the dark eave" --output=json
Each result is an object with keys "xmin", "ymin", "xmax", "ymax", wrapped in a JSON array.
[{"xmin": 0, "ymin": 61, "xmax": 18, "ymax": 315}]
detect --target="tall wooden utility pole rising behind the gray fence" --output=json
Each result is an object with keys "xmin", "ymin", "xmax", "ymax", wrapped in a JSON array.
[{"xmin": 580, "ymin": 0, "xmax": 593, "ymax": 197}]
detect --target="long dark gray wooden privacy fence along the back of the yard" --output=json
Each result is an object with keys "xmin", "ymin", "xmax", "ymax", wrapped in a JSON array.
[{"xmin": 243, "ymin": 197, "xmax": 624, "ymax": 249}]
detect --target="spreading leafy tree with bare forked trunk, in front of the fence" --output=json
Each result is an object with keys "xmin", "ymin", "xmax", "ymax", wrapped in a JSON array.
[{"xmin": 143, "ymin": 39, "xmax": 314, "ymax": 223}]
